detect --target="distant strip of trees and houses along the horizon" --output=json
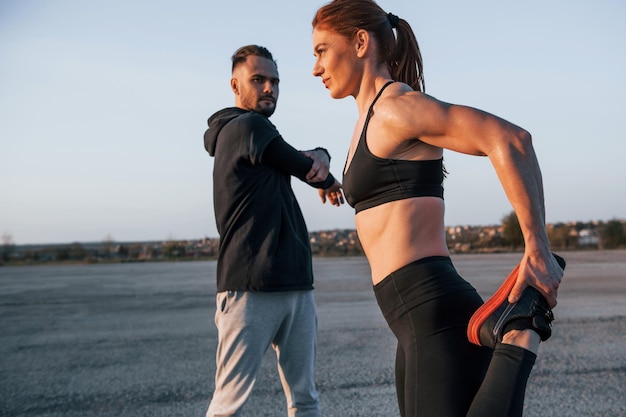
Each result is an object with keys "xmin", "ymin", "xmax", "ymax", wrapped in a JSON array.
[{"xmin": 0, "ymin": 212, "xmax": 626, "ymax": 266}]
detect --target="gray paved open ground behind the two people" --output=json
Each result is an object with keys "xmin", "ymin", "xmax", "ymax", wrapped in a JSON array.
[{"xmin": 0, "ymin": 251, "xmax": 626, "ymax": 417}]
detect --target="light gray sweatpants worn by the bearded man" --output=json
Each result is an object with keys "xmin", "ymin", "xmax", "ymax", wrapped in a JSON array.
[{"xmin": 206, "ymin": 291, "xmax": 321, "ymax": 417}]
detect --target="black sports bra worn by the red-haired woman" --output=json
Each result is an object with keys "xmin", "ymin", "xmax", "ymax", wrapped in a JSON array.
[{"xmin": 342, "ymin": 81, "xmax": 444, "ymax": 213}]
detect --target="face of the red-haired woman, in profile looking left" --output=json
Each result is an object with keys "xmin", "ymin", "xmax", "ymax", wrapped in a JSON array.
[{"xmin": 313, "ymin": 28, "xmax": 361, "ymax": 98}]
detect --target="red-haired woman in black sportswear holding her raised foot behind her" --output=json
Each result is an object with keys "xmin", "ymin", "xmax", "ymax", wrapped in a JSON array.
[{"xmin": 313, "ymin": 0, "xmax": 564, "ymax": 417}]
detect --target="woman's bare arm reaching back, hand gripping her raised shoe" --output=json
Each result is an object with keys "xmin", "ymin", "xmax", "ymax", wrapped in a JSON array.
[{"xmin": 379, "ymin": 87, "xmax": 563, "ymax": 307}]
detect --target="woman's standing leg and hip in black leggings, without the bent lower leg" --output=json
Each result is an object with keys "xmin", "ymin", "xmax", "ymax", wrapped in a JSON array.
[{"xmin": 375, "ymin": 258, "xmax": 492, "ymax": 417}]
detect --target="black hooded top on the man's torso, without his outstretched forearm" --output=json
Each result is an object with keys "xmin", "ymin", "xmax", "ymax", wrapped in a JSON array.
[{"xmin": 204, "ymin": 107, "xmax": 313, "ymax": 291}]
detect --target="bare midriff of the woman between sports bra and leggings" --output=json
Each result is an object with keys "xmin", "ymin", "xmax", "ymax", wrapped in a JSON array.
[{"xmin": 355, "ymin": 197, "xmax": 450, "ymax": 285}]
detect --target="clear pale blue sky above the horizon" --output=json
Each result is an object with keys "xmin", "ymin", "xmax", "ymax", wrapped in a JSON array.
[{"xmin": 0, "ymin": 0, "xmax": 626, "ymax": 244}]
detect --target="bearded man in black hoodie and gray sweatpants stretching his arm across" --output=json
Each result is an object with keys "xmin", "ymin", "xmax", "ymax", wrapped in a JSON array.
[{"xmin": 204, "ymin": 45, "xmax": 344, "ymax": 417}]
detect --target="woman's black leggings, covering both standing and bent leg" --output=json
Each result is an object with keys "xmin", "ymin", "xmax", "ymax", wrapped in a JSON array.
[{"xmin": 374, "ymin": 256, "xmax": 536, "ymax": 417}]
